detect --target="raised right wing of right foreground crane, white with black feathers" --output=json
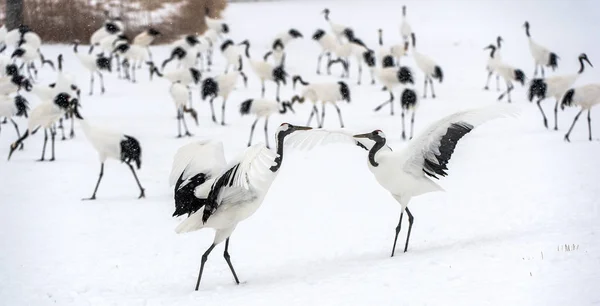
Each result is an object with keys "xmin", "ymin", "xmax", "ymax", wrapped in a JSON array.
[{"xmin": 399, "ymin": 105, "xmax": 518, "ymax": 179}]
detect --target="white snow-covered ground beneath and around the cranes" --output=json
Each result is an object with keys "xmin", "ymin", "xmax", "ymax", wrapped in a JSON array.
[{"xmin": 0, "ymin": 0, "xmax": 600, "ymax": 305}]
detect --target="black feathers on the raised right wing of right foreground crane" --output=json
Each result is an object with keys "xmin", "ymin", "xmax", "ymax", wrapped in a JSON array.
[{"xmin": 423, "ymin": 122, "xmax": 474, "ymax": 179}]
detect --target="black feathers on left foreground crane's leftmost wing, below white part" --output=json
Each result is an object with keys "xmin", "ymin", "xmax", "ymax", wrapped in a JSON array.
[{"xmin": 173, "ymin": 172, "xmax": 210, "ymax": 217}]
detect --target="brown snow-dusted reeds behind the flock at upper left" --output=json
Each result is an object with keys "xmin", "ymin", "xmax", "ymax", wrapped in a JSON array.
[{"xmin": 0, "ymin": 0, "xmax": 232, "ymax": 43}]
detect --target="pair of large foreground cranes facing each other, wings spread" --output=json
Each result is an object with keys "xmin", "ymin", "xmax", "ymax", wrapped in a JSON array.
[{"xmin": 169, "ymin": 105, "xmax": 516, "ymax": 290}]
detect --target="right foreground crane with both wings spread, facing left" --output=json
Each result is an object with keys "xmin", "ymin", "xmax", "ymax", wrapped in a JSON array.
[{"xmin": 286, "ymin": 106, "xmax": 516, "ymax": 256}]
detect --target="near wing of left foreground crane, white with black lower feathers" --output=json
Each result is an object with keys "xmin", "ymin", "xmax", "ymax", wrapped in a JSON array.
[{"xmin": 202, "ymin": 144, "xmax": 277, "ymax": 222}]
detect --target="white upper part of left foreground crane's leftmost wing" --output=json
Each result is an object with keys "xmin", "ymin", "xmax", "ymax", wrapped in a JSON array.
[{"xmin": 169, "ymin": 140, "xmax": 227, "ymax": 186}]
